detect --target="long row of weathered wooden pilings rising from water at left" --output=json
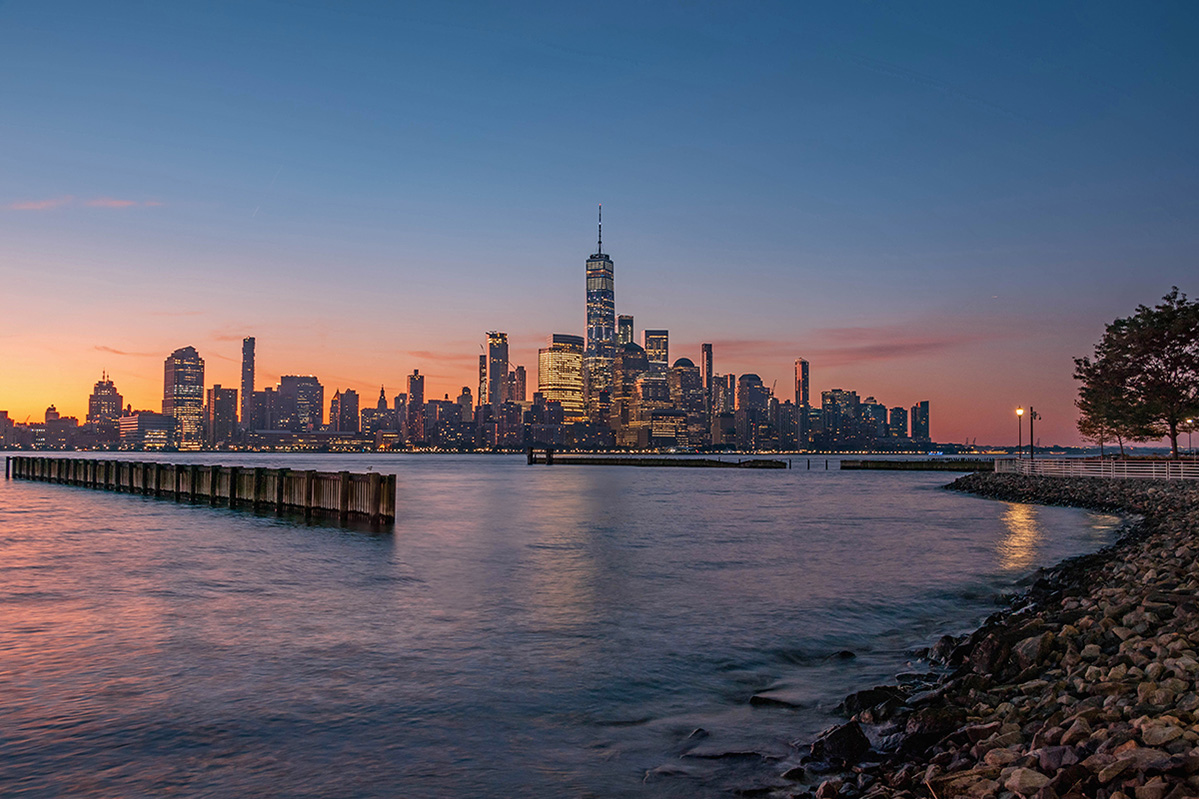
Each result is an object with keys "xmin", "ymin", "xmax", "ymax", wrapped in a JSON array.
[{"xmin": 5, "ymin": 455, "xmax": 396, "ymax": 523}]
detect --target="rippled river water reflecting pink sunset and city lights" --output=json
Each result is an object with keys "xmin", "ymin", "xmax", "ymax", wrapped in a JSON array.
[{"xmin": 0, "ymin": 455, "xmax": 1117, "ymax": 798}]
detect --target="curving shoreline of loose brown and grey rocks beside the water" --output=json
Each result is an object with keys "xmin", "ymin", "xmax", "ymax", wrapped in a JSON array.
[{"xmin": 771, "ymin": 474, "xmax": 1199, "ymax": 799}]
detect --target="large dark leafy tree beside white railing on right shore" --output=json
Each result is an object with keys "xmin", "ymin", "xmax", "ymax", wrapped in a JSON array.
[{"xmin": 1074, "ymin": 287, "xmax": 1199, "ymax": 457}]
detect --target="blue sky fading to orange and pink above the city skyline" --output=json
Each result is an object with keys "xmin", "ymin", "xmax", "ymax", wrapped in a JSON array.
[{"xmin": 0, "ymin": 1, "xmax": 1199, "ymax": 444}]
